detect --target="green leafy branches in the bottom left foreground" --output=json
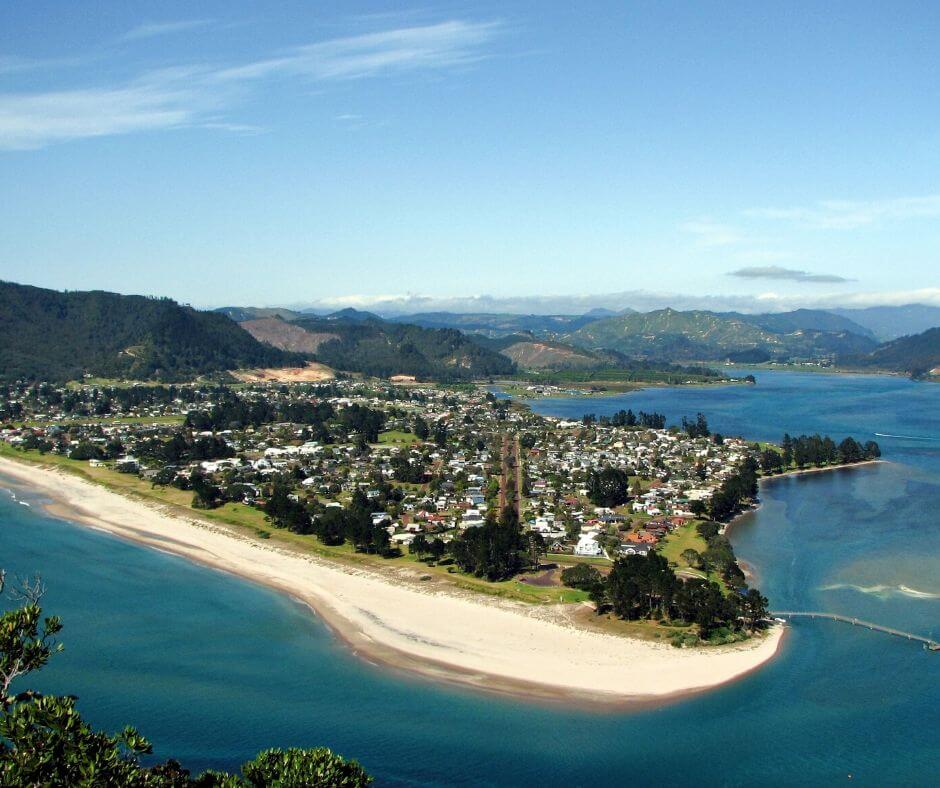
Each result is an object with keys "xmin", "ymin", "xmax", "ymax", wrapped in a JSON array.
[{"xmin": 0, "ymin": 572, "xmax": 372, "ymax": 788}]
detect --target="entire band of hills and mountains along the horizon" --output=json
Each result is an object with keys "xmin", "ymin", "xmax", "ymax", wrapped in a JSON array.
[{"xmin": 0, "ymin": 282, "xmax": 940, "ymax": 381}]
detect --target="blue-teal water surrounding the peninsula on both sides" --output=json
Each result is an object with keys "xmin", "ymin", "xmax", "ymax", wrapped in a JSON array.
[{"xmin": 0, "ymin": 372, "xmax": 940, "ymax": 786}]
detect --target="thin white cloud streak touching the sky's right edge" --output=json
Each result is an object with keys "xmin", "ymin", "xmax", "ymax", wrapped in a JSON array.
[{"xmin": 746, "ymin": 194, "xmax": 940, "ymax": 230}]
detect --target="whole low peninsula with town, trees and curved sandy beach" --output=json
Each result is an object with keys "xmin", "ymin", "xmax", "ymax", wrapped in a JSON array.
[{"xmin": 0, "ymin": 379, "xmax": 878, "ymax": 703}]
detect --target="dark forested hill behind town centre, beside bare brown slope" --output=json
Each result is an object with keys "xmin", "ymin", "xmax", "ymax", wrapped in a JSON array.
[{"xmin": 243, "ymin": 316, "xmax": 515, "ymax": 381}]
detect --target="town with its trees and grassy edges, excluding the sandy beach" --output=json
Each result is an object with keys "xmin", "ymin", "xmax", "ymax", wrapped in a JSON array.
[{"xmin": 0, "ymin": 379, "xmax": 877, "ymax": 645}]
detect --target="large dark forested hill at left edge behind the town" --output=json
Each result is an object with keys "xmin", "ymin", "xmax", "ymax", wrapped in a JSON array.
[{"xmin": 0, "ymin": 282, "xmax": 303, "ymax": 381}]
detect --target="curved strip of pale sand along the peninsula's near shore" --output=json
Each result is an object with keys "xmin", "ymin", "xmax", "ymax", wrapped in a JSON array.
[{"xmin": 0, "ymin": 458, "xmax": 784, "ymax": 708}]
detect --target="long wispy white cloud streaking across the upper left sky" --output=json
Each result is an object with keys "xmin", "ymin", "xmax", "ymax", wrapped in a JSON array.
[{"xmin": 0, "ymin": 20, "xmax": 501, "ymax": 150}]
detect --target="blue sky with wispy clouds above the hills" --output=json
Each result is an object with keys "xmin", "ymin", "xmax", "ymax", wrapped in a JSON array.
[{"xmin": 0, "ymin": 0, "xmax": 940, "ymax": 311}]
